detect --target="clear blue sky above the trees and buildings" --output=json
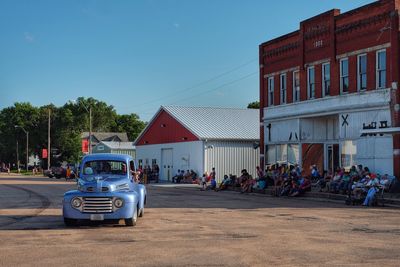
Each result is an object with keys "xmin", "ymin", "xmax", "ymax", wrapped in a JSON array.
[{"xmin": 0, "ymin": 0, "xmax": 373, "ymax": 120}]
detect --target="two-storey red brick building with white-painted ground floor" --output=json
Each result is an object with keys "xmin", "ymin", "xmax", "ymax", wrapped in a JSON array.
[{"xmin": 259, "ymin": 0, "xmax": 400, "ymax": 180}]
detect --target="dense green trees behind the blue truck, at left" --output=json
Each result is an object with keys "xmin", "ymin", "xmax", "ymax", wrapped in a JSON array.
[{"xmin": 0, "ymin": 97, "xmax": 145, "ymax": 169}]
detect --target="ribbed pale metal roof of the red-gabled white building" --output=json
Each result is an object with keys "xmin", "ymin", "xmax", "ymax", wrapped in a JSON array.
[{"xmin": 162, "ymin": 106, "xmax": 260, "ymax": 140}]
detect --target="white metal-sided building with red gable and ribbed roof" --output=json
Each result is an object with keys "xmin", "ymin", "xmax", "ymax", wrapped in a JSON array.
[{"xmin": 134, "ymin": 106, "xmax": 259, "ymax": 181}]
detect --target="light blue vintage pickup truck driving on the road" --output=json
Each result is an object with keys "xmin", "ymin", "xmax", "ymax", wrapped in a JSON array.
[{"xmin": 63, "ymin": 154, "xmax": 147, "ymax": 226}]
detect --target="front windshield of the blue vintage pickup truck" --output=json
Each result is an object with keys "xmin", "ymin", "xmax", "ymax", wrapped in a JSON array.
[{"xmin": 83, "ymin": 160, "xmax": 127, "ymax": 176}]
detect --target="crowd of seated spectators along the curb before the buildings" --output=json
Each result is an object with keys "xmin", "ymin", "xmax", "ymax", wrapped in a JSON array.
[{"xmin": 192, "ymin": 164, "xmax": 395, "ymax": 206}]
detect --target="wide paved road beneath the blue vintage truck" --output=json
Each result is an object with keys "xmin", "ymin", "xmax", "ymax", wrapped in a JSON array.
[{"xmin": 0, "ymin": 176, "xmax": 400, "ymax": 266}]
